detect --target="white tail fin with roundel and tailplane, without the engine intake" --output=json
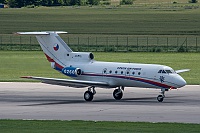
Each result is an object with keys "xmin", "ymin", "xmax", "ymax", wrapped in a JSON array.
[{"xmin": 17, "ymin": 31, "xmax": 73, "ymax": 68}]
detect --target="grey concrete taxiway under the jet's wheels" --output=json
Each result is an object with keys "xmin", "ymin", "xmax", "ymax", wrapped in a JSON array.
[{"xmin": 0, "ymin": 82, "xmax": 200, "ymax": 123}]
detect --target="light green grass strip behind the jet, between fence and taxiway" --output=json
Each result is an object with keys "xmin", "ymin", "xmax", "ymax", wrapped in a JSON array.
[{"xmin": 0, "ymin": 51, "xmax": 200, "ymax": 84}]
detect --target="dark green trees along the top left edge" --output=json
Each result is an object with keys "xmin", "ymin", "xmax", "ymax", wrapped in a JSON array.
[{"xmin": 0, "ymin": 0, "xmax": 100, "ymax": 8}]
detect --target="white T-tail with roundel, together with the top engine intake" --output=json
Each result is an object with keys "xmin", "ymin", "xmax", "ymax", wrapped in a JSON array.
[{"xmin": 17, "ymin": 31, "xmax": 94, "ymax": 71}]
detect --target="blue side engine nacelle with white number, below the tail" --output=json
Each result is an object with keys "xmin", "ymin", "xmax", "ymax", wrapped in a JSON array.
[{"xmin": 62, "ymin": 67, "xmax": 82, "ymax": 77}]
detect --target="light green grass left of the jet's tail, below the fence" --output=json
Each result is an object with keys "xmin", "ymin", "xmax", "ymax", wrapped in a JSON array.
[{"xmin": 0, "ymin": 51, "xmax": 67, "ymax": 81}]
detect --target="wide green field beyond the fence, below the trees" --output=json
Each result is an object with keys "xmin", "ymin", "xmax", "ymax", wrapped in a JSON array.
[{"xmin": 0, "ymin": 3, "xmax": 200, "ymax": 35}]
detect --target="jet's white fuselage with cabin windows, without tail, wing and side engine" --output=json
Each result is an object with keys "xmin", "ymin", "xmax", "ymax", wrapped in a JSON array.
[{"xmin": 61, "ymin": 60, "xmax": 186, "ymax": 89}]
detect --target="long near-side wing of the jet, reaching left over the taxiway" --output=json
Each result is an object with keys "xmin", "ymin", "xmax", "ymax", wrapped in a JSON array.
[{"xmin": 21, "ymin": 76, "xmax": 109, "ymax": 88}]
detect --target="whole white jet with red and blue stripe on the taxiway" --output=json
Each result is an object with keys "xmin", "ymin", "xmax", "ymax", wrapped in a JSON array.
[{"xmin": 16, "ymin": 31, "xmax": 190, "ymax": 102}]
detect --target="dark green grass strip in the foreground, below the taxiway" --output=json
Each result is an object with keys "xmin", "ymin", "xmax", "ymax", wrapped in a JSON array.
[{"xmin": 0, "ymin": 120, "xmax": 200, "ymax": 133}]
